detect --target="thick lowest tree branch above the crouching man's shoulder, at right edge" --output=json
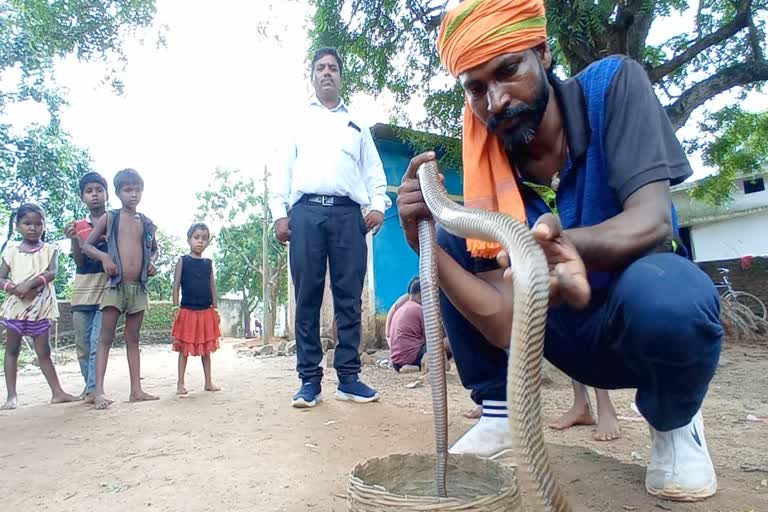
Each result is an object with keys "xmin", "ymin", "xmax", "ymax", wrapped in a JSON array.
[{"xmin": 666, "ymin": 60, "xmax": 768, "ymax": 130}]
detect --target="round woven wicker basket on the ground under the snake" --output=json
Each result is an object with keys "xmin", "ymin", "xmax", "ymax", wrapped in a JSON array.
[{"xmin": 347, "ymin": 454, "xmax": 521, "ymax": 512}]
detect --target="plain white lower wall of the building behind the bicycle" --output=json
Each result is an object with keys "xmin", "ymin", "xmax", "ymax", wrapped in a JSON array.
[{"xmin": 691, "ymin": 212, "xmax": 768, "ymax": 261}]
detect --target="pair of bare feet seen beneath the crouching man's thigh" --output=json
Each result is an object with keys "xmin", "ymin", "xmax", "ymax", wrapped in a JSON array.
[{"xmin": 549, "ymin": 380, "xmax": 621, "ymax": 441}]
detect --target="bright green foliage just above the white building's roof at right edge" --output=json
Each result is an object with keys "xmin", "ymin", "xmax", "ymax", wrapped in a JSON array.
[{"xmin": 690, "ymin": 107, "xmax": 768, "ymax": 206}]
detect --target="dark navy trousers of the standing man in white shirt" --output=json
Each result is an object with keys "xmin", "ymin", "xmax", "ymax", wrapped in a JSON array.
[{"xmin": 288, "ymin": 202, "xmax": 368, "ymax": 382}]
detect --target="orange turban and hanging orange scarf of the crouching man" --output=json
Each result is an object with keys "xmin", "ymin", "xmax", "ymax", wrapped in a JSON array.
[{"xmin": 437, "ymin": 0, "xmax": 547, "ymax": 258}]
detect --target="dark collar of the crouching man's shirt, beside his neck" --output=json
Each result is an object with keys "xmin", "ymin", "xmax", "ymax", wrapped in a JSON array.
[{"xmin": 552, "ymin": 78, "xmax": 592, "ymax": 162}]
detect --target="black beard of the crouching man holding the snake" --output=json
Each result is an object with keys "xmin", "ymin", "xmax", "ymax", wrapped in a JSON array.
[{"xmin": 486, "ymin": 62, "xmax": 549, "ymax": 154}]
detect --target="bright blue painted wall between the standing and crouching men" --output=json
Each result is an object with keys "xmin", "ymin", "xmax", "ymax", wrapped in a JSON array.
[{"xmin": 373, "ymin": 136, "xmax": 462, "ymax": 313}]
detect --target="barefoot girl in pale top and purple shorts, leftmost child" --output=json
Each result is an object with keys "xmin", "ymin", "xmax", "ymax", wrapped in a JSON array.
[{"xmin": 0, "ymin": 204, "xmax": 77, "ymax": 409}]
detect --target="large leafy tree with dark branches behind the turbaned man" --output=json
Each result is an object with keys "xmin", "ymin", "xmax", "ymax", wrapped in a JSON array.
[{"xmin": 309, "ymin": 0, "xmax": 768, "ymax": 197}]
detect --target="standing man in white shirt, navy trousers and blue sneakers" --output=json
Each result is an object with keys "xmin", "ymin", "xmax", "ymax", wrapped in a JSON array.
[{"xmin": 270, "ymin": 48, "xmax": 392, "ymax": 408}]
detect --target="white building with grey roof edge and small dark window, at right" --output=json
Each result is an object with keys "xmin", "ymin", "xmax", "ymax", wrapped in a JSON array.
[{"xmin": 672, "ymin": 173, "xmax": 768, "ymax": 262}]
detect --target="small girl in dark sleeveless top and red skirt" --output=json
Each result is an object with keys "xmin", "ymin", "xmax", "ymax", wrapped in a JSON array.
[{"xmin": 171, "ymin": 222, "xmax": 221, "ymax": 395}]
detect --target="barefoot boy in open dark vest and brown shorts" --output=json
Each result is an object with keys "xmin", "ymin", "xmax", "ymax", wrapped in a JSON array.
[{"xmin": 82, "ymin": 169, "xmax": 158, "ymax": 409}]
